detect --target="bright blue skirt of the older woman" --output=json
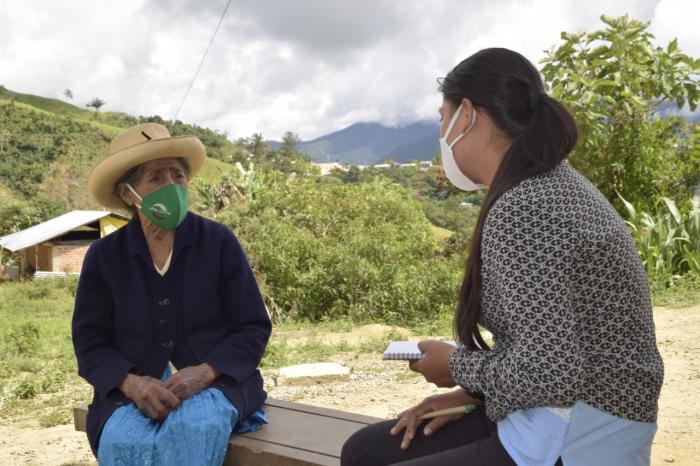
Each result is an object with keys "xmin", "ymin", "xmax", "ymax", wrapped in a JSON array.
[{"xmin": 97, "ymin": 368, "xmax": 267, "ymax": 466}]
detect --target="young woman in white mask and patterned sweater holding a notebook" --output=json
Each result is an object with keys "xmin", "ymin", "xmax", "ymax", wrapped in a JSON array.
[{"xmin": 342, "ymin": 49, "xmax": 663, "ymax": 466}]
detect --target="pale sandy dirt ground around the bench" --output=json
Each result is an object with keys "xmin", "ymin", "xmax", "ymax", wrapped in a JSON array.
[{"xmin": 0, "ymin": 306, "xmax": 700, "ymax": 466}]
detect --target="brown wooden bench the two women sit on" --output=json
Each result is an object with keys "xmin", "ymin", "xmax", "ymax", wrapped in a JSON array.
[{"xmin": 73, "ymin": 398, "xmax": 383, "ymax": 466}]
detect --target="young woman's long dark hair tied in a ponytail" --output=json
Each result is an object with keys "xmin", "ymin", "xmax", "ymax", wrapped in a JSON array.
[{"xmin": 440, "ymin": 48, "xmax": 577, "ymax": 350}]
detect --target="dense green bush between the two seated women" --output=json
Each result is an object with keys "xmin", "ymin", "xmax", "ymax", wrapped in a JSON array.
[{"xmin": 219, "ymin": 174, "xmax": 462, "ymax": 324}]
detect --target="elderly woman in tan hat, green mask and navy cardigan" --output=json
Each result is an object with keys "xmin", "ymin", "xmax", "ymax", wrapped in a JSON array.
[{"xmin": 73, "ymin": 123, "xmax": 271, "ymax": 465}]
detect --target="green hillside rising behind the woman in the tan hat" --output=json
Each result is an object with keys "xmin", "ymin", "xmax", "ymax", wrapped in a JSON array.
[{"xmin": 0, "ymin": 87, "xmax": 245, "ymax": 211}]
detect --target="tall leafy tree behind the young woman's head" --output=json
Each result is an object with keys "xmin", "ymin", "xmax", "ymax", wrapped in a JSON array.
[{"xmin": 542, "ymin": 16, "xmax": 700, "ymax": 208}]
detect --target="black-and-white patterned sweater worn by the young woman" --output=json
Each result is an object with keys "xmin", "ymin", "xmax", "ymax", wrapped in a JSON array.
[{"xmin": 450, "ymin": 161, "xmax": 663, "ymax": 422}]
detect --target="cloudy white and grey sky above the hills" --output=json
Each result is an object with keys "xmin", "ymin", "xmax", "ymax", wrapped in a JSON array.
[{"xmin": 0, "ymin": 0, "xmax": 700, "ymax": 140}]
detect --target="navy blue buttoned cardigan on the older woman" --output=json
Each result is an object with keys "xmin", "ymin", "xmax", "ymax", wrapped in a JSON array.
[{"xmin": 73, "ymin": 212, "xmax": 271, "ymax": 452}]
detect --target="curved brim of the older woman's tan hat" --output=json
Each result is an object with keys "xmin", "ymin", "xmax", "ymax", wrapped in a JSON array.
[{"xmin": 88, "ymin": 136, "xmax": 206, "ymax": 209}]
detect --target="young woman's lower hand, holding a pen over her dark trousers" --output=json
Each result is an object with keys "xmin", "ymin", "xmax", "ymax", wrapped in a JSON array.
[{"xmin": 390, "ymin": 388, "xmax": 481, "ymax": 450}]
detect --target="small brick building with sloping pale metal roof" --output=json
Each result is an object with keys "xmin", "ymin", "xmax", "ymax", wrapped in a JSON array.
[{"xmin": 0, "ymin": 210, "xmax": 129, "ymax": 278}]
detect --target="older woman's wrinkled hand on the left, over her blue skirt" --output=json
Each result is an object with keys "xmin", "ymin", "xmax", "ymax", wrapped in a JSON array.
[{"xmin": 119, "ymin": 374, "xmax": 180, "ymax": 421}]
